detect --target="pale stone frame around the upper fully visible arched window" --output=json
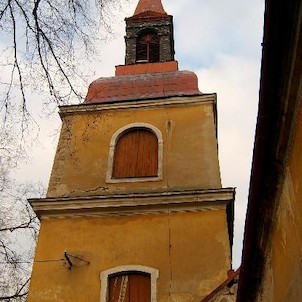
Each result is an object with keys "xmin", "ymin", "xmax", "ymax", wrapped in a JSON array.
[{"xmin": 106, "ymin": 123, "xmax": 163, "ymax": 183}]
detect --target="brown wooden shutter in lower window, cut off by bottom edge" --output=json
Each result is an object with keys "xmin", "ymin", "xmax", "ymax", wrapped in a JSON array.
[{"xmin": 108, "ymin": 272, "xmax": 151, "ymax": 302}]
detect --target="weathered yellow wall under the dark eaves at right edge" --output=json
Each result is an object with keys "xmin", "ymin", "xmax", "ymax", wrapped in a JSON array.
[{"xmin": 259, "ymin": 107, "xmax": 302, "ymax": 302}]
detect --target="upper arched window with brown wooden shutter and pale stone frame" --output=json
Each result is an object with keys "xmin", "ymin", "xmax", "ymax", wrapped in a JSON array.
[{"xmin": 106, "ymin": 122, "xmax": 163, "ymax": 183}]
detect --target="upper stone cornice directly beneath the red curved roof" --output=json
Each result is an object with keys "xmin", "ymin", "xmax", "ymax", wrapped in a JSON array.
[{"xmin": 60, "ymin": 93, "xmax": 216, "ymax": 117}]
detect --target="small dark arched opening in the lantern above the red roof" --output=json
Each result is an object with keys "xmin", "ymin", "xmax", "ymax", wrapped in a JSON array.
[{"xmin": 136, "ymin": 30, "xmax": 159, "ymax": 63}]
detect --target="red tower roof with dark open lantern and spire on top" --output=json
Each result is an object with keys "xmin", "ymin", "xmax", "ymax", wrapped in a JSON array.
[{"xmin": 85, "ymin": 0, "xmax": 201, "ymax": 103}]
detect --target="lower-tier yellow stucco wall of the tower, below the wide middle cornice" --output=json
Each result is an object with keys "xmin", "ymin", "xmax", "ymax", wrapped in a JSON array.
[{"xmin": 28, "ymin": 210, "xmax": 230, "ymax": 302}]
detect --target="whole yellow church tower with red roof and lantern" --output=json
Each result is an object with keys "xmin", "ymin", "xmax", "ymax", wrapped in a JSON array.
[{"xmin": 29, "ymin": 0, "xmax": 235, "ymax": 302}]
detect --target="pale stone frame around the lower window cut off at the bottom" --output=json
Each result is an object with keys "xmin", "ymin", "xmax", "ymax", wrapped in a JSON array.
[{"xmin": 100, "ymin": 265, "xmax": 159, "ymax": 302}]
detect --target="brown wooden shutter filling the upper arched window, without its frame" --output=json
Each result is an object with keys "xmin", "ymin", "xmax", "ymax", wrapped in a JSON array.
[{"xmin": 112, "ymin": 128, "xmax": 158, "ymax": 178}]
